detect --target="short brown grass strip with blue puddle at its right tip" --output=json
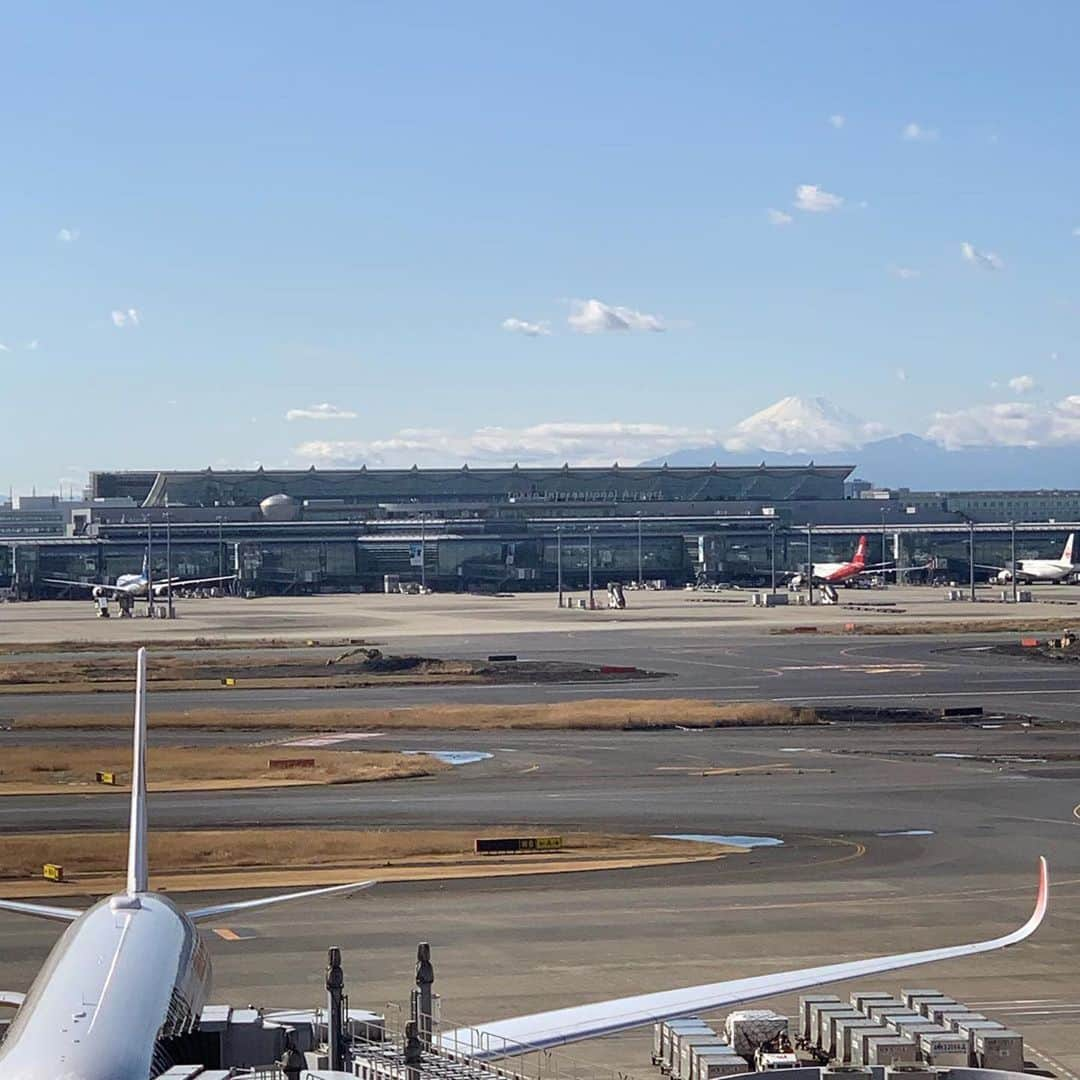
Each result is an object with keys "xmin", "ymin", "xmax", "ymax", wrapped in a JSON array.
[{"xmin": 0, "ymin": 745, "xmax": 450, "ymax": 794}]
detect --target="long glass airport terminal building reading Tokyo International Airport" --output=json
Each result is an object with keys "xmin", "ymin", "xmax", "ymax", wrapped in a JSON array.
[{"xmin": 0, "ymin": 463, "xmax": 1080, "ymax": 596}]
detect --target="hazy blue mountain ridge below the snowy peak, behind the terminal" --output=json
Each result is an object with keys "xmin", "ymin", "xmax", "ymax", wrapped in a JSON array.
[{"xmin": 643, "ymin": 434, "xmax": 1080, "ymax": 491}]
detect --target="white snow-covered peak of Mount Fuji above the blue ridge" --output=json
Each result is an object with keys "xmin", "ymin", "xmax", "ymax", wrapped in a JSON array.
[{"xmin": 724, "ymin": 396, "xmax": 888, "ymax": 454}]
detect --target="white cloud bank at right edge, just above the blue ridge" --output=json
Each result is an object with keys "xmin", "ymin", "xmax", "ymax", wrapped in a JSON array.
[{"xmin": 927, "ymin": 394, "xmax": 1080, "ymax": 450}]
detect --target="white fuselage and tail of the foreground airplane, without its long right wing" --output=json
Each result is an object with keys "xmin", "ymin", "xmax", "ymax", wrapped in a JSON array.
[{"xmin": 0, "ymin": 649, "xmax": 375, "ymax": 1080}]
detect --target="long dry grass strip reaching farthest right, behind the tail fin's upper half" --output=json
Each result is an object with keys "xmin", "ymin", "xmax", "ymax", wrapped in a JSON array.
[{"xmin": 16, "ymin": 698, "xmax": 821, "ymax": 730}]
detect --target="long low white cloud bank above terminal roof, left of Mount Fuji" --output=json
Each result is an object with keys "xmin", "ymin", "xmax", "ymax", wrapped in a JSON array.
[{"xmin": 294, "ymin": 420, "xmax": 716, "ymax": 468}]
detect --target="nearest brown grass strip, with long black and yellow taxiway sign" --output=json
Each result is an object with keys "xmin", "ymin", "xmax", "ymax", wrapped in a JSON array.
[{"xmin": 0, "ymin": 827, "xmax": 741, "ymax": 880}]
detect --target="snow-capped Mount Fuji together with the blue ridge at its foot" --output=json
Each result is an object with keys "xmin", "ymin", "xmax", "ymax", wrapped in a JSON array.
[{"xmin": 643, "ymin": 396, "xmax": 1080, "ymax": 491}]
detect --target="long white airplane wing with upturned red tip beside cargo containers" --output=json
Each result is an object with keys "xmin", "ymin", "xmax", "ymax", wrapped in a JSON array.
[{"xmin": 440, "ymin": 859, "xmax": 1050, "ymax": 1059}]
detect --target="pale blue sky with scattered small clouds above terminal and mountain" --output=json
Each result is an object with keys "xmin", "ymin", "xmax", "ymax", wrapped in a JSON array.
[{"xmin": 0, "ymin": 2, "xmax": 1080, "ymax": 490}]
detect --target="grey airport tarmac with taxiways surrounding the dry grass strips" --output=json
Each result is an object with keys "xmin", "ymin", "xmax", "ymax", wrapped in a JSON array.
[{"xmin": 0, "ymin": 589, "xmax": 1080, "ymax": 1080}]
